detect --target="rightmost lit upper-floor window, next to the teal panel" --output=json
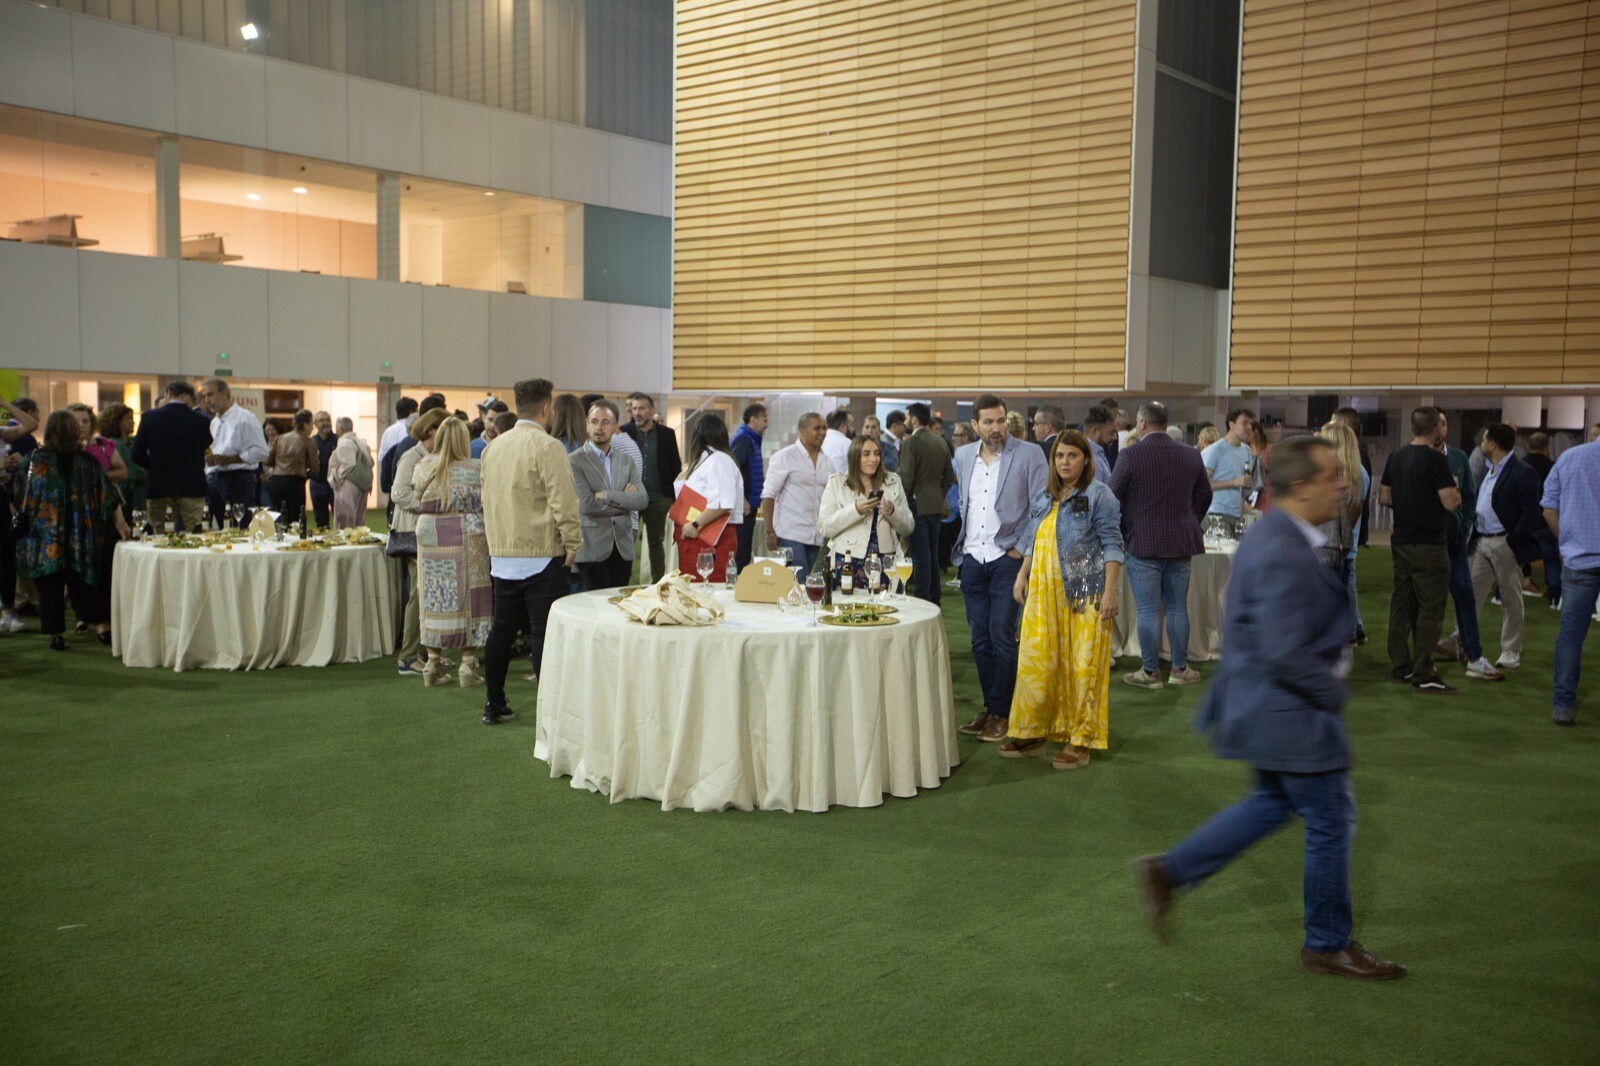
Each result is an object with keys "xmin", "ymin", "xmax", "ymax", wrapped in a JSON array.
[{"xmin": 400, "ymin": 178, "xmax": 584, "ymax": 299}]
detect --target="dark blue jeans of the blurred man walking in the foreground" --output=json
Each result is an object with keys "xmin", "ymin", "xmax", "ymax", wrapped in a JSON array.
[{"xmin": 1162, "ymin": 770, "xmax": 1355, "ymax": 952}]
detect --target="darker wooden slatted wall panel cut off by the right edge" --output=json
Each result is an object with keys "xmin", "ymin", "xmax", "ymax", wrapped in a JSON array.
[{"xmin": 1230, "ymin": 0, "xmax": 1600, "ymax": 387}]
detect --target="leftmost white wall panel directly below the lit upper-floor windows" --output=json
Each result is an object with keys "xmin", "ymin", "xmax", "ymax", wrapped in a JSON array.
[{"xmin": 0, "ymin": 240, "xmax": 83, "ymax": 370}]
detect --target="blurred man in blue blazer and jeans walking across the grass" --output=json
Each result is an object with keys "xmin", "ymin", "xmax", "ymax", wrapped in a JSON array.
[{"xmin": 1136, "ymin": 437, "xmax": 1405, "ymax": 980}]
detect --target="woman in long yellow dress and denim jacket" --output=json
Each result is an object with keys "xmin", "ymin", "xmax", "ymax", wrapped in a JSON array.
[{"xmin": 1000, "ymin": 429, "xmax": 1123, "ymax": 770}]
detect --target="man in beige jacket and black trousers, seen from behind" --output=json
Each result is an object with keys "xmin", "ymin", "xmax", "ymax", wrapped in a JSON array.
[{"xmin": 483, "ymin": 378, "xmax": 584, "ymax": 725}]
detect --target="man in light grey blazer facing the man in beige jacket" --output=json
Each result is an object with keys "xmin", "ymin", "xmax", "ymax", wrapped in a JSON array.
[{"xmin": 568, "ymin": 400, "xmax": 650, "ymax": 591}]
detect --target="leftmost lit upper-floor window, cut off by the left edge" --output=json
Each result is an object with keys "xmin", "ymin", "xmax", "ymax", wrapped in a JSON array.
[{"xmin": 0, "ymin": 106, "xmax": 157, "ymax": 256}]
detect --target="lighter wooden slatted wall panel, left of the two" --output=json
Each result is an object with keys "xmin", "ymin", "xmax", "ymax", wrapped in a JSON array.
[{"xmin": 674, "ymin": 0, "xmax": 1134, "ymax": 389}]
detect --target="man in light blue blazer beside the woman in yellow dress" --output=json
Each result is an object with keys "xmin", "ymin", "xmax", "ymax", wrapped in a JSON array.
[{"xmin": 954, "ymin": 392, "xmax": 1045, "ymax": 743}]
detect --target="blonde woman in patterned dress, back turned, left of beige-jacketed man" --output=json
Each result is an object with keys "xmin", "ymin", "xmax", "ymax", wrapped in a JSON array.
[{"xmin": 411, "ymin": 418, "xmax": 494, "ymax": 688}]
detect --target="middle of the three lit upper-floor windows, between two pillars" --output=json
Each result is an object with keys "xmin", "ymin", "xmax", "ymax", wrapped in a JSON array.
[{"xmin": 178, "ymin": 138, "xmax": 378, "ymax": 279}]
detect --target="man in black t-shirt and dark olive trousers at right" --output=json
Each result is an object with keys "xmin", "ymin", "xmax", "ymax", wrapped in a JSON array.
[{"xmin": 1378, "ymin": 407, "xmax": 1461, "ymax": 693}]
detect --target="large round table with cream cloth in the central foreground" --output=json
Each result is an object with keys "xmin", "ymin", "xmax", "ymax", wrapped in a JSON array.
[{"xmin": 534, "ymin": 591, "xmax": 960, "ymax": 812}]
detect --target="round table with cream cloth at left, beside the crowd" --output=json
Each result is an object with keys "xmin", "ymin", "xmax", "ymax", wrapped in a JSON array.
[{"xmin": 110, "ymin": 541, "xmax": 398, "ymax": 672}]
